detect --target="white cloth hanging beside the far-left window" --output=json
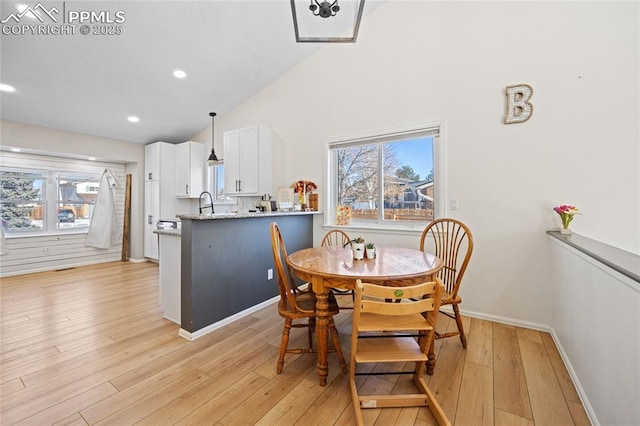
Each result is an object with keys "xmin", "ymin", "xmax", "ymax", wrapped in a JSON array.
[{"xmin": 86, "ymin": 170, "xmax": 122, "ymax": 249}]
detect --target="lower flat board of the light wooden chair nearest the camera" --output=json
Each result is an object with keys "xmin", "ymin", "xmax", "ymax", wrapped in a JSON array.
[{"xmin": 355, "ymin": 336, "xmax": 427, "ymax": 363}]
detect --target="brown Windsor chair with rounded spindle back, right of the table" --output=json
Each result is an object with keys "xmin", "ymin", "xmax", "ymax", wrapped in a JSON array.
[{"xmin": 420, "ymin": 218, "xmax": 473, "ymax": 348}]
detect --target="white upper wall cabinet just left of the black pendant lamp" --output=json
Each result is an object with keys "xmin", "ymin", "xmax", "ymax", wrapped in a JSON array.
[{"xmin": 174, "ymin": 141, "xmax": 207, "ymax": 198}]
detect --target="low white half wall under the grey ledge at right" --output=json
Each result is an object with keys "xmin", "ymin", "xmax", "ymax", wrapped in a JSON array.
[{"xmin": 547, "ymin": 237, "xmax": 640, "ymax": 426}]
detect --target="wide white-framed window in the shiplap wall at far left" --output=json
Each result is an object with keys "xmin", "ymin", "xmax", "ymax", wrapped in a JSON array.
[{"xmin": 0, "ymin": 167, "xmax": 100, "ymax": 235}]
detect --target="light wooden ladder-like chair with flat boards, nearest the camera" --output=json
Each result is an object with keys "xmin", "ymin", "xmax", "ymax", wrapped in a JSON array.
[{"xmin": 349, "ymin": 278, "xmax": 450, "ymax": 425}]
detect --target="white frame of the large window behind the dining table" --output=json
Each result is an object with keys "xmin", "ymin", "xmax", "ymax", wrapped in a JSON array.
[{"xmin": 323, "ymin": 121, "xmax": 447, "ymax": 233}]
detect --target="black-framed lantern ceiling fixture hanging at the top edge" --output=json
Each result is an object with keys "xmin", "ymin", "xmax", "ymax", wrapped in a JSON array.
[{"xmin": 290, "ymin": 0, "xmax": 365, "ymax": 43}]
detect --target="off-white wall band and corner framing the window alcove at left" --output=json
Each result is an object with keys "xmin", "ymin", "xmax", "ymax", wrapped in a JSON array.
[{"xmin": 0, "ymin": 120, "xmax": 144, "ymax": 260}]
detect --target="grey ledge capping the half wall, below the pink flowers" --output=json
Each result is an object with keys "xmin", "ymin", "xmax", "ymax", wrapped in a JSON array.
[{"xmin": 547, "ymin": 231, "xmax": 640, "ymax": 284}]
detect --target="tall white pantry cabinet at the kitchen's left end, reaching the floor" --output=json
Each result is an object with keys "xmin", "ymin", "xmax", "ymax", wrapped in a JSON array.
[{"xmin": 144, "ymin": 142, "xmax": 178, "ymax": 260}]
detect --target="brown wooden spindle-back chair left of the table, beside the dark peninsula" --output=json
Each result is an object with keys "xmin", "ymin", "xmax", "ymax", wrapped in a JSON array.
[{"xmin": 271, "ymin": 222, "xmax": 347, "ymax": 374}]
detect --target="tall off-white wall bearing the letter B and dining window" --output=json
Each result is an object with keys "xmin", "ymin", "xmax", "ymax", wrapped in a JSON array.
[{"xmin": 196, "ymin": 1, "xmax": 640, "ymax": 325}]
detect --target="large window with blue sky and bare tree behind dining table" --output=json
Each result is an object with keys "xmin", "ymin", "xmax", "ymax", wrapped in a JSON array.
[{"xmin": 325, "ymin": 125, "xmax": 442, "ymax": 228}]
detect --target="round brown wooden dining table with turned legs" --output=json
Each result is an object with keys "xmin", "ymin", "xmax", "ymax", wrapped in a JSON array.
[{"xmin": 287, "ymin": 246, "xmax": 443, "ymax": 386}]
